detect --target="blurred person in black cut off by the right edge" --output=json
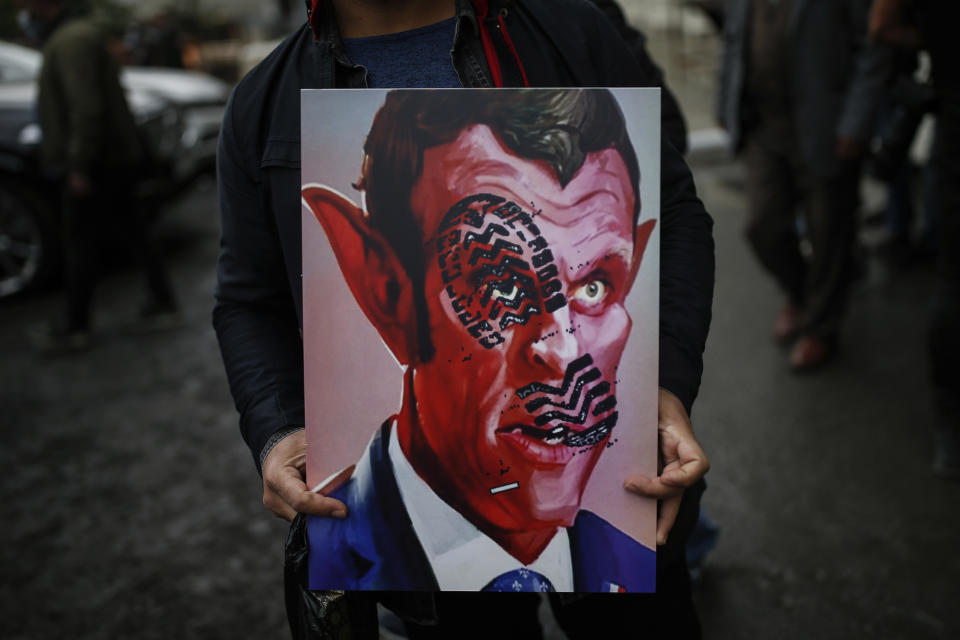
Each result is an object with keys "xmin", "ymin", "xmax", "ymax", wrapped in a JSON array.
[{"xmin": 870, "ymin": 0, "xmax": 960, "ymax": 481}]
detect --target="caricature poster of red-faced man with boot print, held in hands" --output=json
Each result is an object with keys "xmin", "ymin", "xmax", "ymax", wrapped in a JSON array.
[{"xmin": 301, "ymin": 89, "xmax": 660, "ymax": 592}]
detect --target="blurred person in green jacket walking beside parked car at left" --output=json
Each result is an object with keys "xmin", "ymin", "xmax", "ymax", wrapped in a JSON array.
[{"xmin": 27, "ymin": 0, "xmax": 179, "ymax": 350}]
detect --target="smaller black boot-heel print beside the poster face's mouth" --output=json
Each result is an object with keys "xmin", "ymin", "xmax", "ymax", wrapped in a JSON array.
[{"xmin": 517, "ymin": 353, "xmax": 619, "ymax": 447}]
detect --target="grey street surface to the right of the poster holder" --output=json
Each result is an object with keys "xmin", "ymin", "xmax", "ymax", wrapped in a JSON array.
[{"xmin": 694, "ymin": 161, "xmax": 960, "ymax": 639}]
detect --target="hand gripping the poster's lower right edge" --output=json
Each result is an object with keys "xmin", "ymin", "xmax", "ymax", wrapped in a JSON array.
[{"xmin": 623, "ymin": 389, "xmax": 710, "ymax": 545}]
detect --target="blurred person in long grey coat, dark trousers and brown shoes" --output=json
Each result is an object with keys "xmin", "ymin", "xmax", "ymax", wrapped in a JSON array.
[{"xmin": 717, "ymin": 0, "xmax": 888, "ymax": 371}]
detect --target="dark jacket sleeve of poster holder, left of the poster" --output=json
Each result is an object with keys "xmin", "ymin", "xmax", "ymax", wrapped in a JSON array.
[{"xmin": 213, "ymin": 91, "xmax": 304, "ymax": 472}]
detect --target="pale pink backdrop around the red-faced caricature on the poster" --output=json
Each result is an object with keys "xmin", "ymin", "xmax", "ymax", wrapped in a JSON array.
[{"xmin": 301, "ymin": 89, "xmax": 660, "ymax": 548}]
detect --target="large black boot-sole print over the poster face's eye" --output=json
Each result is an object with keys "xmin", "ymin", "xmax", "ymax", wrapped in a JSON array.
[{"xmin": 437, "ymin": 193, "xmax": 567, "ymax": 349}]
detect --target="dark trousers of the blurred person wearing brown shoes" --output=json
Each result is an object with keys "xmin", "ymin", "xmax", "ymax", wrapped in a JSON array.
[{"xmin": 745, "ymin": 118, "xmax": 860, "ymax": 339}]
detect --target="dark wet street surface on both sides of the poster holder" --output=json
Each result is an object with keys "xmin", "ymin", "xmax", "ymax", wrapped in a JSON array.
[{"xmin": 0, "ymin": 149, "xmax": 960, "ymax": 640}]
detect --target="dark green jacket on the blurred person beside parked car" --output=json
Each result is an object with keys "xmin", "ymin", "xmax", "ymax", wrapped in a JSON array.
[{"xmin": 37, "ymin": 15, "xmax": 143, "ymax": 175}]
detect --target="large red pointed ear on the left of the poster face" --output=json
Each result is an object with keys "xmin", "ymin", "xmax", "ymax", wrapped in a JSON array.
[{"xmin": 301, "ymin": 185, "xmax": 417, "ymax": 365}]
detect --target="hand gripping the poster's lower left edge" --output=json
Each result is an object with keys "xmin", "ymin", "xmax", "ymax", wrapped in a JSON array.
[{"xmin": 263, "ymin": 429, "xmax": 347, "ymax": 520}]
